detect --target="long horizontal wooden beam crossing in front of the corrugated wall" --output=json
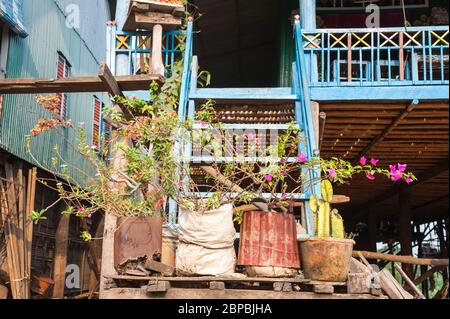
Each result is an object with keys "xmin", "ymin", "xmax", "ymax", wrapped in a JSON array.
[{"xmin": 0, "ymin": 74, "xmax": 165, "ymax": 94}]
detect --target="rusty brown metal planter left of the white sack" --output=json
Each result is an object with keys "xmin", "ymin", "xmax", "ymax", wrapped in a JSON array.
[{"xmin": 114, "ymin": 217, "xmax": 163, "ymax": 266}]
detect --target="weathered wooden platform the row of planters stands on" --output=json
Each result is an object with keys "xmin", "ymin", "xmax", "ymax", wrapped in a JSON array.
[{"xmin": 100, "ymin": 276, "xmax": 387, "ymax": 299}]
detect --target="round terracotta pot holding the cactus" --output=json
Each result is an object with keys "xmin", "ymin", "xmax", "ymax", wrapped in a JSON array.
[{"xmin": 300, "ymin": 238, "xmax": 355, "ymax": 282}]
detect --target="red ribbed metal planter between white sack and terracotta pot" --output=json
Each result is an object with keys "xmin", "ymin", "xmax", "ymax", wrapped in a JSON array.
[{"xmin": 238, "ymin": 211, "xmax": 300, "ymax": 269}]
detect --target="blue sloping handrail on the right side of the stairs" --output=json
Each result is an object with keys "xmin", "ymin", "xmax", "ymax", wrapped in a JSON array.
[{"xmin": 293, "ymin": 19, "xmax": 321, "ymax": 236}]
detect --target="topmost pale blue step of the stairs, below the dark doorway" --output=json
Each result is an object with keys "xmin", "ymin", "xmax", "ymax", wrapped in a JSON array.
[{"xmin": 189, "ymin": 88, "xmax": 297, "ymax": 101}]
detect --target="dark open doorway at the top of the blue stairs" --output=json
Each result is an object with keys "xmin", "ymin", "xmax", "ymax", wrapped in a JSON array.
[{"xmin": 191, "ymin": 0, "xmax": 281, "ymax": 87}]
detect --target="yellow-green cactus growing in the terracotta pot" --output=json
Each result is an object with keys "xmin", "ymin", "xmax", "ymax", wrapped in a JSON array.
[{"xmin": 309, "ymin": 180, "xmax": 345, "ymax": 238}]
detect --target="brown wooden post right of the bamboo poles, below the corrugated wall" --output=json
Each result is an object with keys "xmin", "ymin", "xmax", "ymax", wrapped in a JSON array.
[{"xmin": 53, "ymin": 215, "xmax": 70, "ymax": 299}]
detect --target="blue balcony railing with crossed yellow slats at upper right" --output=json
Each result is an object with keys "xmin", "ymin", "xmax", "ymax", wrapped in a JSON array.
[{"xmin": 297, "ymin": 26, "xmax": 449, "ymax": 87}]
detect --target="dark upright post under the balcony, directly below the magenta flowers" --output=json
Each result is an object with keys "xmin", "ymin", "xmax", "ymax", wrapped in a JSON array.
[{"xmin": 398, "ymin": 186, "xmax": 412, "ymax": 276}]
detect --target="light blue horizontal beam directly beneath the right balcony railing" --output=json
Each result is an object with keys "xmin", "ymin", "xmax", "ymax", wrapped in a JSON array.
[{"xmin": 311, "ymin": 82, "xmax": 449, "ymax": 102}]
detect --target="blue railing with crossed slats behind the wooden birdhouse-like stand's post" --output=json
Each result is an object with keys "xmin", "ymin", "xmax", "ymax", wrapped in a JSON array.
[{"xmin": 114, "ymin": 30, "xmax": 182, "ymax": 77}]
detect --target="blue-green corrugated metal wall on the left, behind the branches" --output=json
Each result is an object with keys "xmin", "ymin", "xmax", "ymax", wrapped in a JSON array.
[{"xmin": 0, "ymin": 0, "xmax": 107, "ymax": 181}]
